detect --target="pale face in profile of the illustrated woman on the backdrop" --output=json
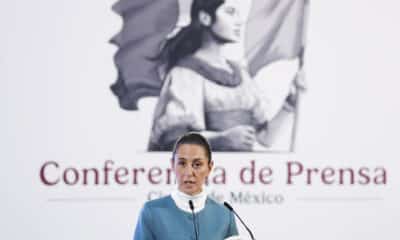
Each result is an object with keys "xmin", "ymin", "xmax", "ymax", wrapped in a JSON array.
[{"xmin": 211, "ymin": 0, "xmax": 243, "ymax": 42}]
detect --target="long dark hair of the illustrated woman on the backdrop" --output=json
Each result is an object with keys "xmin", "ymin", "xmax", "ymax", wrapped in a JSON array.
[{"xmin": 155, "ymin": 0, "xmax": 225, "ymax": 72}]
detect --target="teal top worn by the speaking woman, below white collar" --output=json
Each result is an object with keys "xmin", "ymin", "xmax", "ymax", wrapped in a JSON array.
[{"xmin": 133, "ymin": 196, "xmax": 238, "ymax": 240}]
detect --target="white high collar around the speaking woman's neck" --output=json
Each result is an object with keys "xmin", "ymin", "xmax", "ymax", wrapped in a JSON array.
[{"xmin": 171, "ymin": 189, "xmax": 207, "ymax": 213}]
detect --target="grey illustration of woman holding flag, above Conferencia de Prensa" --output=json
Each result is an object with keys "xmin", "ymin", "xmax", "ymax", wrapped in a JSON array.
[{"xmin": 111, "ymin": 0, "xmax": 308, "ymax": 152}]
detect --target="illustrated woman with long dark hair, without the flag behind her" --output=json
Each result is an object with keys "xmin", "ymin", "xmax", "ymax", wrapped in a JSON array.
[{"xmin": 149, "ymin": 0, "xmax": 286, "ymax": 151}]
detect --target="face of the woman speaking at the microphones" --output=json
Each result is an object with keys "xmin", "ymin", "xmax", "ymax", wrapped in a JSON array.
[{"xmin": 172, "ymin": 144, "xmax": 213, "ymax": 195}]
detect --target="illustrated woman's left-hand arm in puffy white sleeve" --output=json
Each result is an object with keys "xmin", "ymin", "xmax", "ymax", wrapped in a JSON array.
[{"xmin": 150, "ymin": 67, "xmax": 206, "ymax": 149}]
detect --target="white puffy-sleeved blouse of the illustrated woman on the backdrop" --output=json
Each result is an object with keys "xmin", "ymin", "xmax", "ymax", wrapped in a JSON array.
[{"xmin": 150, "ymin": 60, "xmax": 273, "ymax": 148}]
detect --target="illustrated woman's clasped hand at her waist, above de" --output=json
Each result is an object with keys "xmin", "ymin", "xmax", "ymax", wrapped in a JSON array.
[{"xmin": 222, "ymin": 125, "xmax": 256, "ymax": 151}]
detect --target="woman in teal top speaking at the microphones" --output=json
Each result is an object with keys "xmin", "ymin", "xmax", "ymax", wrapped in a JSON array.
[{"xmin": 133, "ymin": 133, "xmax": 238, "ymax": 240}]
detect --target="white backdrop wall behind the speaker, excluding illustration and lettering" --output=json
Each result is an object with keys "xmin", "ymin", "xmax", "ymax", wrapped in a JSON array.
[{"xmin": 0, "ymin": 0, "xmax": 400, "ymax": 240}]
